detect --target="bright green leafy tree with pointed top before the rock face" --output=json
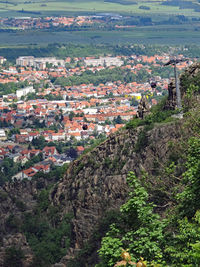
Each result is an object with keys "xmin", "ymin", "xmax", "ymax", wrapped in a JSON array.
[{"xmin": 99, "ymin": 172, "xmax": 165, "ymax": 266}]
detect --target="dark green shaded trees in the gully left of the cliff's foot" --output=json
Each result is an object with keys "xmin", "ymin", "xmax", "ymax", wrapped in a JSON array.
[{"xmin": 22, "ymin": 189, "xmax": 72, "ymax": 266}]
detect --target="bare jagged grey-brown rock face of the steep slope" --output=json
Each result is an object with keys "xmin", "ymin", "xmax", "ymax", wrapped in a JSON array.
[{"xmin": 51, "ymin": 123, "xmax": 184, "ymax": 264}]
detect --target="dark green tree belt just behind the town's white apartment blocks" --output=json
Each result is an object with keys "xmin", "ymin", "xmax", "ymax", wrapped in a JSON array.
[{"xmin": 0, "ymin": 43, "xmax": 167, "ymax": 61}]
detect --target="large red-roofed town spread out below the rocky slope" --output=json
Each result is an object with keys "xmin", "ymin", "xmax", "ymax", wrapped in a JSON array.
[{"xmin": 0, "ymin": 53, "xmax": 196, "ymax": 184}]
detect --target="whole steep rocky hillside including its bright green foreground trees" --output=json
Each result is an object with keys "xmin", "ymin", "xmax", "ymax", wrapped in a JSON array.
[{"xmin": 0, "ymin": 64, "xmax": 200, "ymax": 267}]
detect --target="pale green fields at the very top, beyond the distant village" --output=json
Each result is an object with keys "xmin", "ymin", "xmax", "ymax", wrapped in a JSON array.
[{"xmin": 0, "ymin": 0, "xmax": 200, "ymax": 17}]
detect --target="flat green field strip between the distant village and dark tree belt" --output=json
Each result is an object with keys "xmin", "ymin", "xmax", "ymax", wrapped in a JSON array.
[{"xmin": 0, "ymin": 25, "xmax": 200, "ymax": 46}]
